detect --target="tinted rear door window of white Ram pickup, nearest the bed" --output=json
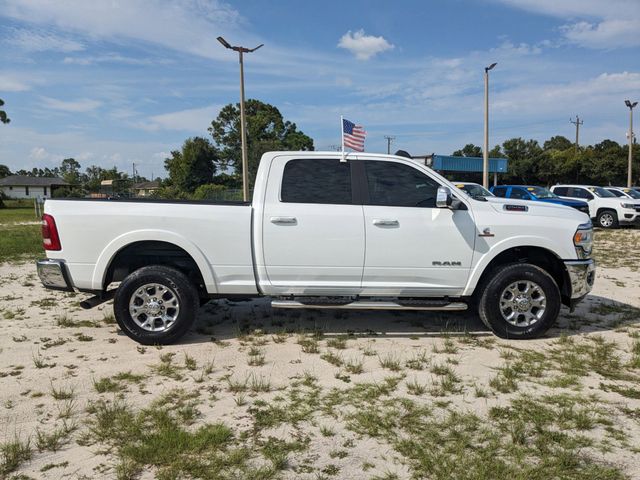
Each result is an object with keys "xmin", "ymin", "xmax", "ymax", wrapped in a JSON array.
[{"xmin": 281, "ymin": 158, "xmax": 351, "ymax": 203}]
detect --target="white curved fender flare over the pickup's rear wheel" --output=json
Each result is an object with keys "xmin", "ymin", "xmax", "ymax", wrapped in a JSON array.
[{"xmin": 91, "ymin": 229, "xmax": 218, "ymax": 293}]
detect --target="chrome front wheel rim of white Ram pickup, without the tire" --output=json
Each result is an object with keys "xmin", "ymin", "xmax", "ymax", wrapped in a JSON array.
[{"xmin": 500, "ymin": 280, "xmax": 547, "ymax": 327}]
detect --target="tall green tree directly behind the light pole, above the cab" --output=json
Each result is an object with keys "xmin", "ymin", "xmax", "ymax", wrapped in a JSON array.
[{"xmin": 209, "ymin": 99, "xmax": 313, "ymax": 185}]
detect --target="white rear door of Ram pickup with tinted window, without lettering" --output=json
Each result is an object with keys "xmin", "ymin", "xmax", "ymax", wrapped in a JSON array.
[{"xmin": 257, "ymin": 156, "xmax": 364, "ymax": 295}]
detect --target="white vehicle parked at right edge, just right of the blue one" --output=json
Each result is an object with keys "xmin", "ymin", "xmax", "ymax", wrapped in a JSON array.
[{"xmin": 551, "ymin": 185, "xmax": 640, "ymax": 228}]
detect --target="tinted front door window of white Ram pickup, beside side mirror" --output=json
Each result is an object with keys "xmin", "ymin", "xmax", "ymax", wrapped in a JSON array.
[{"xmin": 364, "ymin": 161, "xmax": 440, "ymax": 208}]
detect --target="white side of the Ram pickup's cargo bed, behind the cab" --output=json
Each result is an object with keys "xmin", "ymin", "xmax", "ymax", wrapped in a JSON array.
[{"xmin": 45, "ymin": 199, "xmax": 257, "ymax": 294}]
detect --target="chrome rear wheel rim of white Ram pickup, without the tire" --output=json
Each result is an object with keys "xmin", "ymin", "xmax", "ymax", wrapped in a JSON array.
[{"xmin": 129, "ymin": 283, "xmax": 180, "ymax": 332}]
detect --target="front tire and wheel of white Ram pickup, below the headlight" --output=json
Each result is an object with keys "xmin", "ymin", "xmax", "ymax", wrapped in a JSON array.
[{"xmin": 478, "ymin": 263, "xmax": 561, "ymax": 339}]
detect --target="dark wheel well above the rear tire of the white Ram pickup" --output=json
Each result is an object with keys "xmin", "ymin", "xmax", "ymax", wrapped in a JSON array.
[{"xmin": 103, "ymin": 241, "xmax": 206, "ymax": 293}]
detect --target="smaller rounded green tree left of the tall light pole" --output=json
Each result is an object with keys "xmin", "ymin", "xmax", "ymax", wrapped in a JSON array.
[{"xmin": 164, "ymin": 137, "xmax": 218, "ymax": 193}]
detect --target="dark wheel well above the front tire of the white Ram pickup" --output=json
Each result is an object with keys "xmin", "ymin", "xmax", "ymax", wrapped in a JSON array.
[{"xmin": 476, "ymin": 246, "xmax": 570, "ymax": 302}]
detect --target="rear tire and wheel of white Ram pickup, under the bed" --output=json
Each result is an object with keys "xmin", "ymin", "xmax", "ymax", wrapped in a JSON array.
[{"xmin": 113, "ymin": 265, "xmax": 199, "ymax": 345}]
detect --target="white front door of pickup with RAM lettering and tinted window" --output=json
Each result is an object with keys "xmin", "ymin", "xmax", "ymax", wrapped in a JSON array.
[{"xmin": 360, "ymin": 160, "xmax": 476, "ymax": 296}]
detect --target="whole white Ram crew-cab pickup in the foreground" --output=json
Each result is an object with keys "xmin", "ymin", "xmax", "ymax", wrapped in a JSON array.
[{"xmin": 37, "ymin": 152, "xmax": 595, "ymax": 344}]
